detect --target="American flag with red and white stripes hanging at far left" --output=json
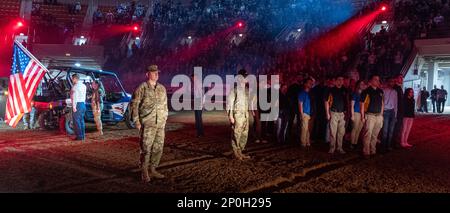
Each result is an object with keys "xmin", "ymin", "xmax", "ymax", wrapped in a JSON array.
[{"xmin": 5, "ymin": 41, "xmax": 47, "ymax": 127}]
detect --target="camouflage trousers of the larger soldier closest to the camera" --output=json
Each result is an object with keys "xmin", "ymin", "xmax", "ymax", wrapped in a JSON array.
[{"xmin": 139, "ymin": 125, "xmax": 165, "ymax": 168}]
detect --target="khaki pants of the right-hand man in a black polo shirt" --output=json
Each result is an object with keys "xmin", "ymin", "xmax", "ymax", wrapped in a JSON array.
[{"xmin": 363, "ymin": 114, "xmax": 383, "ymax": 155}]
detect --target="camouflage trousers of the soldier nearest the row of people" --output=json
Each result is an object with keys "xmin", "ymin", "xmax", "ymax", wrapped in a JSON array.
[{"xmin": 231, "ymin": 112, "xmax": 249, "ymax": 152}]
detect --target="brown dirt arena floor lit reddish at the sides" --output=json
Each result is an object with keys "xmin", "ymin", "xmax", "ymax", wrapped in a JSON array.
[{"xmin": 0, "ymin": 112, "xmax": 450, "ymax": 193}]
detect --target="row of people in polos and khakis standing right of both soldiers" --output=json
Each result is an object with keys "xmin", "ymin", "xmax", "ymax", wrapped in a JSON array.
[{"xmin": 270, "ymin": 75, "xmax": 415, "ymax": 156}]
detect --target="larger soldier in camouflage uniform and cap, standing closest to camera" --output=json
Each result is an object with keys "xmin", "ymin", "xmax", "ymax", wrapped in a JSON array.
[{"xmin": 130, "ymin": 65, "xmax": 168, "ymax": 182}]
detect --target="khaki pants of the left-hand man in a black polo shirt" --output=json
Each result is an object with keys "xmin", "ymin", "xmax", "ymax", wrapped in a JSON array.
[{"xmin": 330, "ymin": 112, "xmax": 345, "ymax": 152}]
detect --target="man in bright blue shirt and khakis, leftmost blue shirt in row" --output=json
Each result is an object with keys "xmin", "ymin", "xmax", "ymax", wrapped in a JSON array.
[{"xmin": 298, "ymin": 78, "xmax": 313, "ymax": 148}]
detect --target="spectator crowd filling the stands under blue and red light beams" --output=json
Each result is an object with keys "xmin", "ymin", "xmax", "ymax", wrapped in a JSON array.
[{"xmin": 26, "ymin": 0, "xmax": 450, "ymax": 90}]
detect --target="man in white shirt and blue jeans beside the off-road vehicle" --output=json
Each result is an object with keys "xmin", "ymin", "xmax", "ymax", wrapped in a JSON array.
[{"xmin": 70, "ymin": 74, "xmax": 86, "ymax": 141}]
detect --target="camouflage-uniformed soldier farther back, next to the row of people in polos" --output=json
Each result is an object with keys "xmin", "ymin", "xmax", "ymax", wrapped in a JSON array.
[{"xmin": 227, "ymin": 69, "xmax": 250, "ymax": 160}]
